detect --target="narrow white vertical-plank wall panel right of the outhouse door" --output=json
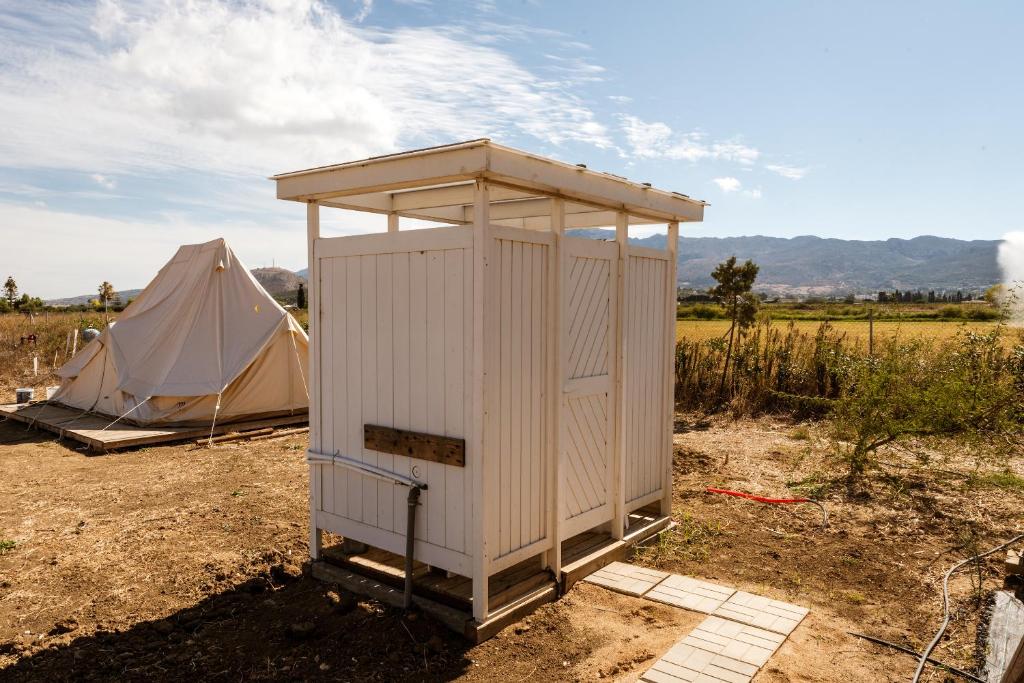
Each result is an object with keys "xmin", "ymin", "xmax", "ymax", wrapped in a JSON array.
[{"xmin": 624, "ymin": 255, "xmax": 669, "ymax": 505}]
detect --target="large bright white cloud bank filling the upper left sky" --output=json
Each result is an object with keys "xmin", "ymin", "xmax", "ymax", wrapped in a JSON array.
[{"xmin": 0, "ymin": 0, "xmax": 611, "ymax": 175}]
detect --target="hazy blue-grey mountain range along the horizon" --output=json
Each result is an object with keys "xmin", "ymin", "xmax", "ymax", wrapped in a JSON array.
[{"xmin": 49, "ymin": 235, "xmax": 1001, "ymax": 305}]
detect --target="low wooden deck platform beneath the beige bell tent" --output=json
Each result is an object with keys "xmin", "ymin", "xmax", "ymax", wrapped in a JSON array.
[{"xmin": 0, "ymin": 402, "xmax": 309, "ymax": 453}]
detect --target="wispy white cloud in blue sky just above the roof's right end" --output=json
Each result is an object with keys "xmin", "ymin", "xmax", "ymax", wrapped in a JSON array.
[{"xmin": 620, "ymin": 115, "xmax": 761, "ymax": 166}]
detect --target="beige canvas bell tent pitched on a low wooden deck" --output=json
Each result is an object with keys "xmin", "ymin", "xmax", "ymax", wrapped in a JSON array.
[{"xmin": 49, "ymin": 240, "xmax": 308, "ymax": 425}]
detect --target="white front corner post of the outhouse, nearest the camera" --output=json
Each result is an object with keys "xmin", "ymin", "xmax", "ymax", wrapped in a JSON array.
[{"xmin": 466, "ymin": 181, "xmax": 494, "ymax": 622}]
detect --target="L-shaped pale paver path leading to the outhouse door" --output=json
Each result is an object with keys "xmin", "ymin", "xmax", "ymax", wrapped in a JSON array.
[{"xmin": 585, "ymin": 562, "xmax": 808, "ymax": 683}]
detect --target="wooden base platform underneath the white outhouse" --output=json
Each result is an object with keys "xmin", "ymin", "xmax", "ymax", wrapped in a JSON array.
[{"xmin": 313, "ymin": 511, "xmax": 673, "ymax": 642}]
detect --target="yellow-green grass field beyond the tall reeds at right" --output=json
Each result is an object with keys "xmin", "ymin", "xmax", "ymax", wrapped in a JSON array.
[{"xmin": 676, "ymin": 321, "xmax": 1021, "ymax": 344}]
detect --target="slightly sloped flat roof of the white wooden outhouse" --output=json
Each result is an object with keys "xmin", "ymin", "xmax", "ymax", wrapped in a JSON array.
[{"xmin": 271, "ymin": 138, "xmax": 707, "ymax": 228}]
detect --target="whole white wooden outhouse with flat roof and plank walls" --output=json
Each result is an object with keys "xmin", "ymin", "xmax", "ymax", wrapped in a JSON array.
[{"xmin": 273, "ymin": 139, "xmax": 705, "ymax": 638}]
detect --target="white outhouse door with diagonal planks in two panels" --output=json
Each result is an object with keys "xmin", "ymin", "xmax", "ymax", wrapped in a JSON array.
[{"xmin": 561, "ymin": 238, "xmax": 618, "ymax": 538}]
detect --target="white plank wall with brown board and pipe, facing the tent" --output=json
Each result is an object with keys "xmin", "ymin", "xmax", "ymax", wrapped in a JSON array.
[{"xmin": 319, "ymin": 228, "xmax": 473, "ymax": 566}]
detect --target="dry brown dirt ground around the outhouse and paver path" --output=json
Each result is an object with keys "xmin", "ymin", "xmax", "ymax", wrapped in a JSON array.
[{"xmin": 0, "ymin": 419, "xmax": 1024, "ymax": 683}]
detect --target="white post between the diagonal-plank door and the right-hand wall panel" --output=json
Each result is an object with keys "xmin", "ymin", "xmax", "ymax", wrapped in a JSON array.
[{"xmin": 611, "ymin": 211, "xmax": 630, "ymax": 540}]
